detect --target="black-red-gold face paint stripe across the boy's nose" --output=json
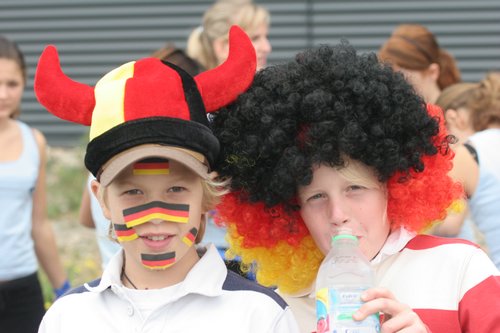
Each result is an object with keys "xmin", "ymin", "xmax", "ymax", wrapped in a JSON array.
[{"xmin": 123, "ymin": 201, "xmax": 189, "ymax": 228}]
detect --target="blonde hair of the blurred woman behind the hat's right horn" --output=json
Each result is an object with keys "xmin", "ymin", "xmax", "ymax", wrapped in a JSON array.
[{"xmin": 186, "ymin": 1, "xmax": 270, "ymax": 70}]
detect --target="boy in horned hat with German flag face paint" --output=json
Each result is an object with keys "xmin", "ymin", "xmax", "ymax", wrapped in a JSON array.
[{"xmin": 35, "ymin": 27, "xmax": 298, "ymax": 333}]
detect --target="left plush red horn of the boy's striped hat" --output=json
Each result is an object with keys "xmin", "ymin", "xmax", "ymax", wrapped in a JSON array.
[{"xmin": 34, "ymin": 45, "xmax": 95, "ymax": 126}]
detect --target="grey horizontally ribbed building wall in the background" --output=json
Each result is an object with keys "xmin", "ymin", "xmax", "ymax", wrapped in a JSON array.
[{"xmin": 0, "ymin": 0, "xmax": 500, "ymax": 146}]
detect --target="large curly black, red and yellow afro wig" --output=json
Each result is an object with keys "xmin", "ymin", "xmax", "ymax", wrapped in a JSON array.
[{"xmin": 212, "ymin": 42, "xmax": 462, "ymax": 293}]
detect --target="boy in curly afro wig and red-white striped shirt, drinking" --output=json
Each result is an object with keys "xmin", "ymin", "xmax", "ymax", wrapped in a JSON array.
[{"xmin": 212, "ymin": 42, "xmax": 500, "ymax": 333}]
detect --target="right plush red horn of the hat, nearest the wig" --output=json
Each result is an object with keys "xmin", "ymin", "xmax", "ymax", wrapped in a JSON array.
[{"xmin": 195, "ymin": 25, "xmax": 257, "ymax": 112}]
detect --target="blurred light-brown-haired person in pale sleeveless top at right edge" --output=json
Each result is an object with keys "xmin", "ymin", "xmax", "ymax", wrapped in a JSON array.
[{"xmin": 433, "ymin": 73, "xmax": 500, "ymax": 268}]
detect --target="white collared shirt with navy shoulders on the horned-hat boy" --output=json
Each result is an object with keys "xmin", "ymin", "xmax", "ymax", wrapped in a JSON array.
[{"xmin": 39, "ymin": 245, "xmax": 299, "ymax": 333}]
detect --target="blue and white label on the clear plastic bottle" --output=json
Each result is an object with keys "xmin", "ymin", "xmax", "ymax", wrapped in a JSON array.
[{"xmin": 316, "ymin": 286, "xmax": 380, "ymax": 333}]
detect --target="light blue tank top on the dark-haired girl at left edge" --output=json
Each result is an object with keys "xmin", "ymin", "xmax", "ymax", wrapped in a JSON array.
[{"xmin": 0, "ymin": 121, "xmax": 40, "ymax": 280}]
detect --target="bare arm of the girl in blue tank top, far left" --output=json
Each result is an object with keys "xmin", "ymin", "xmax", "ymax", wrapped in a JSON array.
[{"xmin": 31, "ymin": 130, "xmax": 66, "ymax": 289}]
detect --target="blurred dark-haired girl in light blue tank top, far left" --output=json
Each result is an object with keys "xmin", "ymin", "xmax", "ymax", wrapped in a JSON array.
[{"xmin": 0, "ymin": 36, "xmax": 70, "ymax": 333}]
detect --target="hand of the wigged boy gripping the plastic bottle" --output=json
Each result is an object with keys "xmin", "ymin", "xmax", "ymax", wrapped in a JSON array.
[{"xmin": 353, "ymin": 288, "xmax": 429, "ymax": 333}]
